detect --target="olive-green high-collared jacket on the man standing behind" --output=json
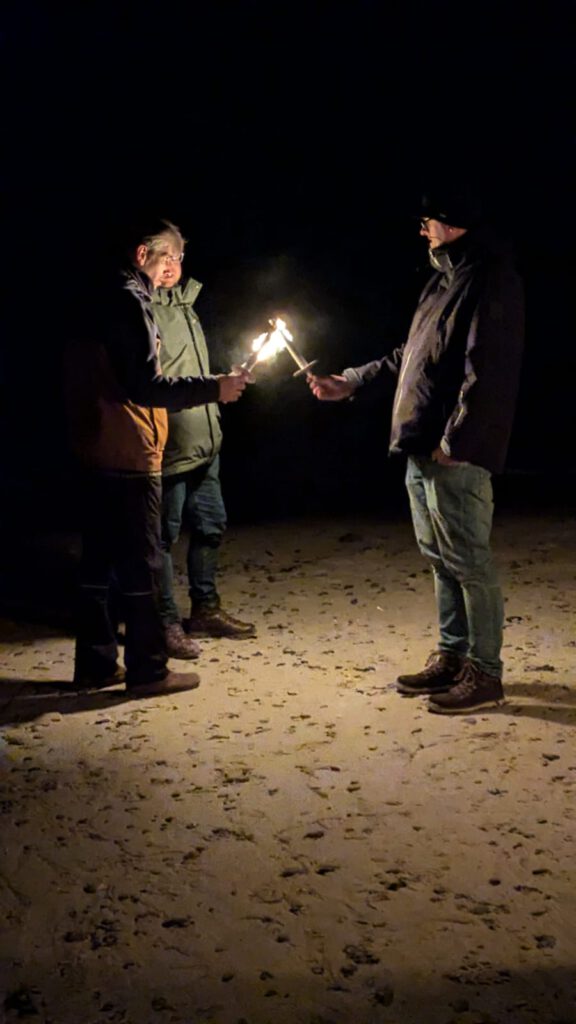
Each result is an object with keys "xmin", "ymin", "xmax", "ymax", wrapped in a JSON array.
[{"xmin": 152, "ymin": 279, "xmax": 222, "ymax": 476}]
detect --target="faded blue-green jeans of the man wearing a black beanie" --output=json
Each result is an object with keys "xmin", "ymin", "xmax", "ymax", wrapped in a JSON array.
[{"xmin": 406, "ymin": 456, "xmax": 503, "ymax": 677}]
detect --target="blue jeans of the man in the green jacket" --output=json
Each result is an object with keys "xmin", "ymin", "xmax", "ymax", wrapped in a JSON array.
[{"xmin": 160, "ymin": 456, "xmax": 227, "ymax": 626}]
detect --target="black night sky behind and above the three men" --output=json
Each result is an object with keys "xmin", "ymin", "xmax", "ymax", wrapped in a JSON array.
[{"xmin": 2, "ymin": 0, "xmax": 576, "ymax": 516}]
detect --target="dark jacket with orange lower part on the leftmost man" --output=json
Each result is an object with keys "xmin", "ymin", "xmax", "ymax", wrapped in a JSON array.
[{"xmin": 65, "ymin": 270, "xmax": 218, "ymax": 473}]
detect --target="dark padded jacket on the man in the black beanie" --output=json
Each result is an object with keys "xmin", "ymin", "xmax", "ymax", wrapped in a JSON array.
[{"xmin": 344, "ymin": 229, "xmax": 524, "ymax": 472}]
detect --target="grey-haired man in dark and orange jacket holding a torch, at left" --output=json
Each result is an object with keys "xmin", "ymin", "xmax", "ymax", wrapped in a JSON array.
[{"xmin": 67, "ymin": 221, "xmax": 248, "ymax": 697}]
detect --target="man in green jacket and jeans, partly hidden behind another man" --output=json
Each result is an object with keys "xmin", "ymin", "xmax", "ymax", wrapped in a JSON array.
[{"xmin": 152, "ymin": 233, "xmax": 255, "ymax": 657}]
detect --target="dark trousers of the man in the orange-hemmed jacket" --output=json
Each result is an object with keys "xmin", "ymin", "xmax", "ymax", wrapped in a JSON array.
[{"xmin": 75, "ymin": 473, "xmax": 167, "ymax": 685}]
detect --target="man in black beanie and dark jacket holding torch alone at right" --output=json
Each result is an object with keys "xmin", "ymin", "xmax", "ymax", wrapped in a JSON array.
[{"xmin": 308, "ymin": 193, "xmax": 524, "ymax": 715}]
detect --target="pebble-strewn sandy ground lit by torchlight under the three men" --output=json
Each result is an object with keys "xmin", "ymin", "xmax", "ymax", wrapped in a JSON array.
[{"xmin": 0, "ymin": 515, "xmax": 576, "ymax": 1024}]
